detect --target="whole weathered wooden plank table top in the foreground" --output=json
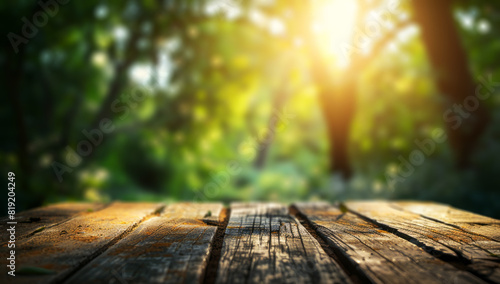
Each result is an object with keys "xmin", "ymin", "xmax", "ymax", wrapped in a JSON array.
[{"xmin": 0, "ymin": 201, "xmax": 500, "ymax": 284}]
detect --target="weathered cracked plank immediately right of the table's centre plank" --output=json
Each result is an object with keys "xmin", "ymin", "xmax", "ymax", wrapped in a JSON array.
[{"xmin": 294, "ymin": 203, "xmax": 484, "ymax": 283}]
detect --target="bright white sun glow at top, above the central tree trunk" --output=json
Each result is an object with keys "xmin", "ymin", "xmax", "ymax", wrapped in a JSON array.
[{"xmin": 311, "ymin": 0, "xmax": 357, "ymax": 66}]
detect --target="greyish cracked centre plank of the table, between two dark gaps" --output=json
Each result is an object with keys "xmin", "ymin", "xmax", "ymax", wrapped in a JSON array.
[{"xmin": 216, "ymin": 203, "xmax": 350, "ymax": 283}]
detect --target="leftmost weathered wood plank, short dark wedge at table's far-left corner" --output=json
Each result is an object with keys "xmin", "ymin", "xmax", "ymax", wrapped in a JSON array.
[{"xmin": 0, "ymin": 203, "xmax": 105, "ymax": 244}]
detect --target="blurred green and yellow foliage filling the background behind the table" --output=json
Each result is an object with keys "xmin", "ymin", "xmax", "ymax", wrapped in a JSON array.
[{"xmin": 0, "ymin": 0, "xmax": 500, "ymax": 218}]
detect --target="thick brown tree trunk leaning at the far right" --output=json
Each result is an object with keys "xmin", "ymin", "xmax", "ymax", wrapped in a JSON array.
[{"xmin": 412, "ymin": 0, "xmax": 490, "ymax": 168}]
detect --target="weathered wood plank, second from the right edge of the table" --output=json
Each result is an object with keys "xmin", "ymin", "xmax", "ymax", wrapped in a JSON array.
[{"xmin": 346, "ymin": 201, "xmax": 500, "ymax": 283}]
